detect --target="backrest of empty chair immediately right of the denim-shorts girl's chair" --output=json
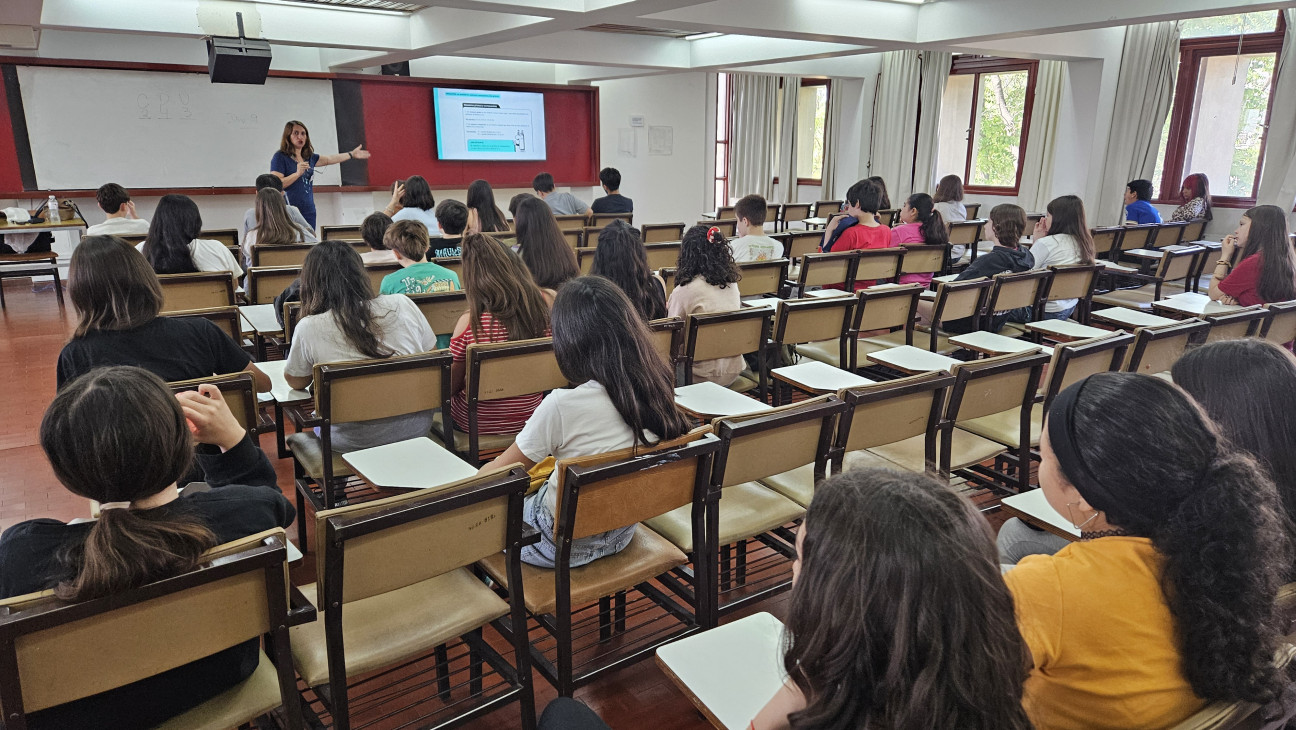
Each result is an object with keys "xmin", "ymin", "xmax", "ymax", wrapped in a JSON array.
[{"xmin": 712, "ymin": 395, "xmax": 846, "ymax": 489}]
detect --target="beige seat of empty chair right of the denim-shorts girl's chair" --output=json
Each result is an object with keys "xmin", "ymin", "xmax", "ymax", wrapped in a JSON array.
[{"xmin": 644, "ymin": 481, "xmax": 806, "ymax": 552}]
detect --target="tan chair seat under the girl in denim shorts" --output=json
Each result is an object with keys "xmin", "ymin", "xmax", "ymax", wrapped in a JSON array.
[{"xmin": 478, "ymin": 525, "xmax": 688, "ymax": 615}]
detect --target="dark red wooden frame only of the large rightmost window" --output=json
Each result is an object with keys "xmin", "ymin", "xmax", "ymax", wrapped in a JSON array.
[{"xmin": 1152, "ymin": 13, "xmax": 1287, "ymax": 209}]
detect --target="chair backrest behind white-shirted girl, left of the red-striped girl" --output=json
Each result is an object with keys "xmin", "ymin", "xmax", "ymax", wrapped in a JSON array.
[{"xmin": 315, "ymin": 350, "xmax": 451, "ymax": 425}]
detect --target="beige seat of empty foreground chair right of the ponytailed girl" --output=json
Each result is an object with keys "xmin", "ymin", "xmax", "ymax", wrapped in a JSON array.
[{"xmin": 289, "ymin": 568, "xmax": 508, "ymax": 687}]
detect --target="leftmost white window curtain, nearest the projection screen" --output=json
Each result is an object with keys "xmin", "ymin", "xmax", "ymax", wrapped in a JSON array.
[{"xmin": 715, "ymin": 74, "xmax": 779, "ymax": 206}]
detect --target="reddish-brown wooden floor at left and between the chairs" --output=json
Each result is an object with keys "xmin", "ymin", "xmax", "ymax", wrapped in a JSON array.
[{"xmin": 0, "ymin": 279, "xmax": 998, "ymax": 730}]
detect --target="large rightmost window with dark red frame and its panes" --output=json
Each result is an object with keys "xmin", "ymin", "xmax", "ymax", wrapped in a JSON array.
[{"xmin": 1152, "ymin": 10, "xmax": 1283, "ymax": 207}]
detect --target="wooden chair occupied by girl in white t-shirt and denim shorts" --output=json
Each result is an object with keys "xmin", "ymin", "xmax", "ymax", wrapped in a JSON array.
[{"xmin": 480, "ymin": 425, "xmax": 719, "ymax": 696}]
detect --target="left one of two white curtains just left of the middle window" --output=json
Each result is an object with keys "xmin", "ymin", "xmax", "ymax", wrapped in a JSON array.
[{"xmin": 867, "ymin": 51, "xmax": 923, "ymax": 202}]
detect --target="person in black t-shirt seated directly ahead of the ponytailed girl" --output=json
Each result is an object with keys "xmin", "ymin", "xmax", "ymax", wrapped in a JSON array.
[{"xmin": 58, "ymin": 236, "xmax": 270, "ymax": 392}]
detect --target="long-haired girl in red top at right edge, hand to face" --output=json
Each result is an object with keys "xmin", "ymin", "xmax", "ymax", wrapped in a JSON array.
[{"xmin": 1209, "ymin": 205, "xmax": 1296, "ymax": 307}]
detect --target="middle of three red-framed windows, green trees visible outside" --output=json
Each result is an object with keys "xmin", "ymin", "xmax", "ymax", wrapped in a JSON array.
[{"xmin": 937, "ymin": 56, "xmax": 1038, "ymax": 194}]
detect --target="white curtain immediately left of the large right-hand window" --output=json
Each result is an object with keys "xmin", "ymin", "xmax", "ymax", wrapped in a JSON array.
[{"xmin": 1087, "ymin": 21, "xmax": 1179, "ymax": 226}]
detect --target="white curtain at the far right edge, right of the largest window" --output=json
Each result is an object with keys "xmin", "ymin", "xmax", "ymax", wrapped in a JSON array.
[{"xmin": 1256, "ymin": 9, "xmax": 1296, "ymax": 213}]
